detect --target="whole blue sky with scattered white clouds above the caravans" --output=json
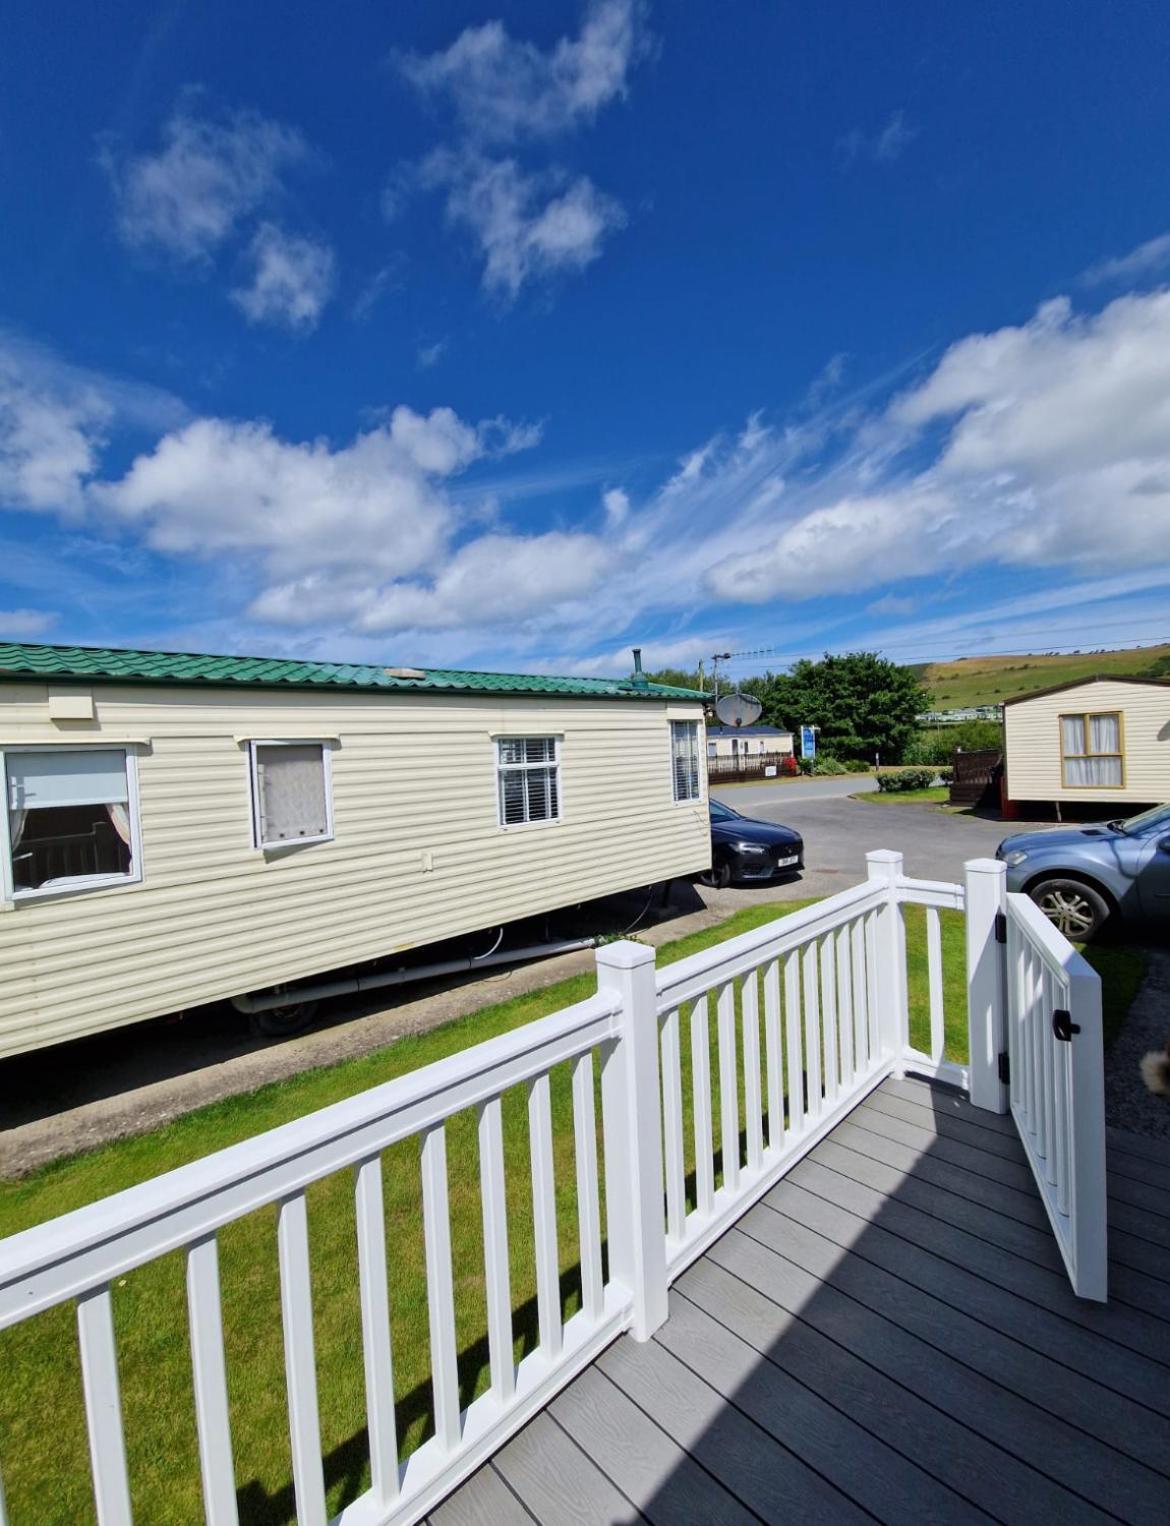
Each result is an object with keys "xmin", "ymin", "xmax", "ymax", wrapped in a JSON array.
[{"xmin": 0, "ymin": 0, "xmax": 1170, "ymax": 671}]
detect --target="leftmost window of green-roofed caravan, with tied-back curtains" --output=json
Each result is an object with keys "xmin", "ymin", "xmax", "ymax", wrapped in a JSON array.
[{"xmin": 5, "ymin": 748, "xmax": 140, "ymax": 896}]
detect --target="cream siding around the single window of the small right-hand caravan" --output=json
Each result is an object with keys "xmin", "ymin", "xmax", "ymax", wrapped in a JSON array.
[{"xmin": 1004, "ymin": 679, "xmax": 1170, "ymax": 804}]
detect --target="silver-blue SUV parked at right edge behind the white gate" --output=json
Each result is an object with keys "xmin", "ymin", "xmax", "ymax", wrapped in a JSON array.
[{"xmin": 996, "ymin": 806, "xmax": 1170, "ymax": 942}]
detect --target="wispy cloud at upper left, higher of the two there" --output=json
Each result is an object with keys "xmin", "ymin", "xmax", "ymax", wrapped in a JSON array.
[{"xmin": 102, "ymin": 102, "xmax": 311, "ymax": 262}]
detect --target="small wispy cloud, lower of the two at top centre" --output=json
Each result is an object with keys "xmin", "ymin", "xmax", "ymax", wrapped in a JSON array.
[{"xmin": 421, "ymin": 150, "xmax": 625, "ymax": 298}]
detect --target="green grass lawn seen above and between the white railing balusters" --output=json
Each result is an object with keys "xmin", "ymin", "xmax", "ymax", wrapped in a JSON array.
[{"xmin": 0, "ymin": 902, "xmax": 1147, "ymax": 1526}]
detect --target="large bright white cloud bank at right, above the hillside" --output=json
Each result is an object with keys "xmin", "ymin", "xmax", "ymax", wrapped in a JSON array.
[{"xmin": 708, "ymin": 291, "xmax": 1170, "ymax": 603}]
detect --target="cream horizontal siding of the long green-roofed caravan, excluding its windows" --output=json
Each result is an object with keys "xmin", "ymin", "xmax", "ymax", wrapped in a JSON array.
[{"xmin": 0, "ymin": 684, "xmax": 711, "ymax": 1054}]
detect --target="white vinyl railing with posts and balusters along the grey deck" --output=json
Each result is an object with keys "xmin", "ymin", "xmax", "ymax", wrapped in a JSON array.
[{"xmin": 0, "ymin": 853, "xmax": 1104, "ymax": 1526}]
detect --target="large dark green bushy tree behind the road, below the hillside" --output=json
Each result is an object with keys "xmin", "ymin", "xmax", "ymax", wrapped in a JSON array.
[{"xmin": 744, "ymin": 652, "xmax": 929, "ymax": 763}]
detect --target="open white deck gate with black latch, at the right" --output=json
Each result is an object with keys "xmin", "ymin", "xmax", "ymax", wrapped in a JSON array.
[{"xmin": 1001, "ymin": 894, "xmax": 1107, "ymax": 1302}]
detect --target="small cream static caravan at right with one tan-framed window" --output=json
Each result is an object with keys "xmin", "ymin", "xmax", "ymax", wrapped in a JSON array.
[{"xmin": 1004, "ymin": 678, "xmax": 1170, "ymax": 815}]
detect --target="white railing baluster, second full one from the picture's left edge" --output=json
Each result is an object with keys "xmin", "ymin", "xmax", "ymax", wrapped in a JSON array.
[{"xmin": 187, "ymin": 1235, "xmax": 239, "ymax": 1526}]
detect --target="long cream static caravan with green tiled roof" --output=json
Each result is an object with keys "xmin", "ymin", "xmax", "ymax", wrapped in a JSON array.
[{"xmin": 0, "ymin": 642, "xmax": 711, "ymax": 1056}]
